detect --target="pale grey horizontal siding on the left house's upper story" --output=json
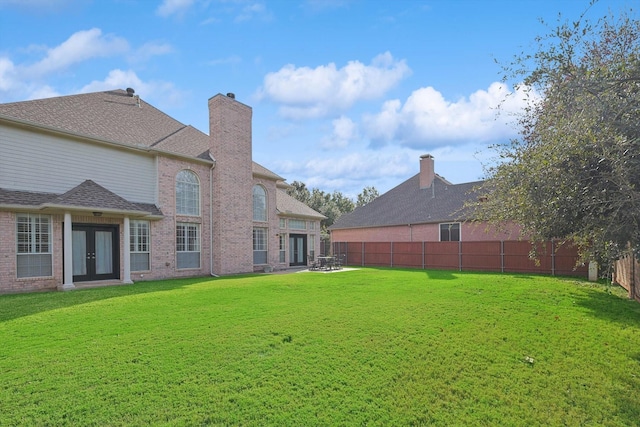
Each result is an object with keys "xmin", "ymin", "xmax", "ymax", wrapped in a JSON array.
[{"xmin": 0, "ymin": 126, "xmax": 157, "ymax": 203}]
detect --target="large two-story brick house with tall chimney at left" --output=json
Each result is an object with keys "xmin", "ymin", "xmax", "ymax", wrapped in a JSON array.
[{"xmin": 0, "ymin": 89, "xmax": 324, "ymax": 292}]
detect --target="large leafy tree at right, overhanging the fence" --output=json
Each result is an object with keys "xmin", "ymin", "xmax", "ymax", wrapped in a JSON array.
[{"xmin": 476, "ymin": 5, "xmax": 640, "ymax": 272}]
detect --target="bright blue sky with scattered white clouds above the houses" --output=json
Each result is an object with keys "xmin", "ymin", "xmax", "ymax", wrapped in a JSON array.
[{"xmin": 0, "ymin": 0, "xmax": 636, "ymax": 198}]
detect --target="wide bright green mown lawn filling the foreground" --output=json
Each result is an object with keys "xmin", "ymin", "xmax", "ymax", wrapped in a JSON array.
[{"xmin": 0, "ymin": 269, "xmax": 640, "ymax": 426}]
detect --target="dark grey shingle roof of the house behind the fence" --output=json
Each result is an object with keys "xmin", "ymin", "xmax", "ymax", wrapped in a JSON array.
[{"xmin": 329, "ymin": 174, "xmax": 481, "ymax": 230}]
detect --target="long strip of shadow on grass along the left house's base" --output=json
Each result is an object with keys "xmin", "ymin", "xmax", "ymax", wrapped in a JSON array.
[{"xmin": 0, "ymin": 274, "xmax": 259, "ymax": 322}]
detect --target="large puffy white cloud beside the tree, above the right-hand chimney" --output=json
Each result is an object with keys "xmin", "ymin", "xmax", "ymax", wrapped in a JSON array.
[{"xmin": 362, "ymin": 83, "xmax": 527, "ymax": 147}]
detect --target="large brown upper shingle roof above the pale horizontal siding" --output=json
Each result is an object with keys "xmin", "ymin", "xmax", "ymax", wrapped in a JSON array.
[{"xmin": 0, "ymin": 89, "xmax": 209, "ymax": 157}]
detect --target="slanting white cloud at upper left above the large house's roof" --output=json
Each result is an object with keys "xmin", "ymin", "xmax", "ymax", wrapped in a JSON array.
[{"xmin": 27, "ymin": 28, "xmax": 129, "ymax": 76}]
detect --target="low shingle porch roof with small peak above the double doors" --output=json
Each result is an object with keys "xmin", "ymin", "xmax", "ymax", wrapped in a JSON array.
[{"xmin": 0, "ymin": 180, "xmax": 162, "ymax": 216}]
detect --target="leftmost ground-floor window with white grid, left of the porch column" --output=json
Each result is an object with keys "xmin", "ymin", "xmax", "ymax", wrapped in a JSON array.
[{"xmin": 16, "ymin": 214, "xmax": 53, "ymax": 277}]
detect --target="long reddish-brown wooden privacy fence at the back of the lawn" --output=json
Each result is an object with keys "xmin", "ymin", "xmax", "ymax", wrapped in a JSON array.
[{"xmin": 332, "ymin": 240, "xmax": 589, "ymax": 277}]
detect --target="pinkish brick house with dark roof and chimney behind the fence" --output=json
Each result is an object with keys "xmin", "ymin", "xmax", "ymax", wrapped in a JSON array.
[{"xmin": 329, "ymin": 154, "xmax": 518, "ymax": 242}]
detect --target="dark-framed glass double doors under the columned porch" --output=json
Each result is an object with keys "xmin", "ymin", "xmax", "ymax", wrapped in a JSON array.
[{"xmin": 72, "ymin": 224, "xmax": 120, "ymax": 282}]
